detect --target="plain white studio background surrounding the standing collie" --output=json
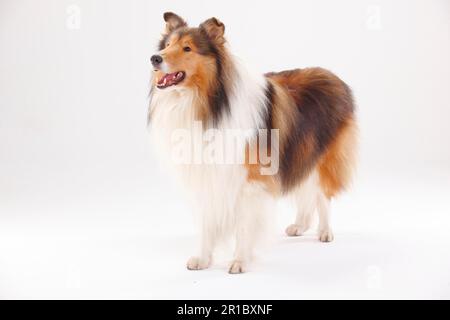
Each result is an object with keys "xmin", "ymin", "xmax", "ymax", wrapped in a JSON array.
[{"xmin": 0, "ymin": 0, "xmax": 450, "ymax": 299}]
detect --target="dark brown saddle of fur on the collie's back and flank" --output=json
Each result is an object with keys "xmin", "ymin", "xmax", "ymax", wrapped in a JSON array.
[{"xmin": 266, "ymin": 68, "xmax": 354, "ymax": 194}]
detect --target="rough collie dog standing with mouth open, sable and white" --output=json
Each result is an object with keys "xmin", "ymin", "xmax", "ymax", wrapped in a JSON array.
[{"xmin": 148, "ymin": 12, "xmax": 356, "ymax": 273}]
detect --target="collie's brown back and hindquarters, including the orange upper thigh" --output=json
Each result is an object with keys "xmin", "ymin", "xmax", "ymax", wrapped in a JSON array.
[{"xmin": 248, "ymin": 68, "xmax": 356, "ymax": 197}]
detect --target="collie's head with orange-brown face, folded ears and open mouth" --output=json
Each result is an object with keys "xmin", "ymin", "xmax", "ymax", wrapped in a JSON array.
[{"xmin": 151, "ymin": 12, "xmax": 229, "ymax": 90}]
